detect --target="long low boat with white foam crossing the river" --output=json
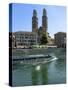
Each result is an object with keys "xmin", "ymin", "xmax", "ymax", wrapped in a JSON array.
[{"xmin": 12, "ymin": 54, "xmax": 57, "ymax": 65}]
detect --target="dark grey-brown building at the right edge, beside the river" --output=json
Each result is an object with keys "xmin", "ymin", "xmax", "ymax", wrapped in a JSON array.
[{"xmin": 54, "ymin": 32, "xmax": 66, "ymax": 47}]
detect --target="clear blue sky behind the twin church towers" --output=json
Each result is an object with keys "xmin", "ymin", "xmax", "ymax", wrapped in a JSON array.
[{"xmin": 12, "ymin": 3, "xmax": 66, "ymax": 37}]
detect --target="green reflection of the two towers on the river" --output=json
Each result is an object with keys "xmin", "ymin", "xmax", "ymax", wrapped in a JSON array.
[{"xmin": 32, "ymin": 65, "xmax": 48, "ymax": 85}]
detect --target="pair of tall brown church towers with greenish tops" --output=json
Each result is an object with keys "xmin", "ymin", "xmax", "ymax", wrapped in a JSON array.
[{"xmin": 32, "ymin": 9, "xmax": 47, "ymax": 33}]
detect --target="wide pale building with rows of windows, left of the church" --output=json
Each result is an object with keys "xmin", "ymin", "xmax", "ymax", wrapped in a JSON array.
[{"xmin": 14, "ymin": 32, "xmax": 37, "ymax": 48}]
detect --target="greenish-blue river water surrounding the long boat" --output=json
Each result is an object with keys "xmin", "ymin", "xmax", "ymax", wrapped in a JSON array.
[{"xmin": 12, "ymin": 48, "xmax": 66, "ymax": 86}]
